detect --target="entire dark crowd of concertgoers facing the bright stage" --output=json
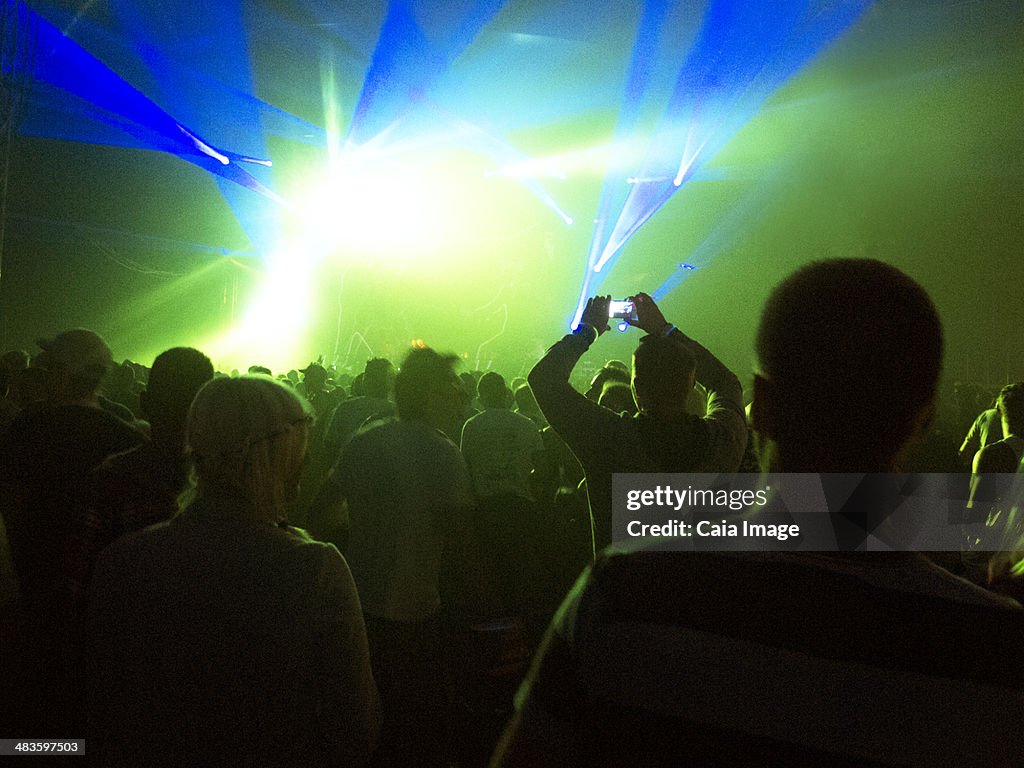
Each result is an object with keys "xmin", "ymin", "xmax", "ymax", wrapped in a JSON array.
[{"xmin": 0, "ymin": 259, "xmax": 1024, "ymax": 768}]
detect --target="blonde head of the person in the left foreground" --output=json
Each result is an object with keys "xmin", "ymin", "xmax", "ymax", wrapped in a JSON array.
[{"xmin": 187, "ymin": 376, "xmax": 312, "ymax": 522}]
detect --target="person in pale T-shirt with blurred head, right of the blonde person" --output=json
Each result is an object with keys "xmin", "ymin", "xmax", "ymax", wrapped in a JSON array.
[{"xmin": 310, "ymin": 348, "xmax": 471, "ymax": 766}]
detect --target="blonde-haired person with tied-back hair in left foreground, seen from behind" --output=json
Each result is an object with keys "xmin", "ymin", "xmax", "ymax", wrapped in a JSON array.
[{"xmin": 88, "ymin": 376, "xmax": 380, "ymax": 766}]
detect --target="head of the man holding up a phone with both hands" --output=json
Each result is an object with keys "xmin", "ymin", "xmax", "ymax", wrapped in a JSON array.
[{"xmin": 632, "ymin": 335, "xmax": 696, "ymax": 416}]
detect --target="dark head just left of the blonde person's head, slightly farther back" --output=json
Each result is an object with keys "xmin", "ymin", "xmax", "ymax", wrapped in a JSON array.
[{"xmin": 139, "ymin": 347, "xmax": 213, "ymax": 438}]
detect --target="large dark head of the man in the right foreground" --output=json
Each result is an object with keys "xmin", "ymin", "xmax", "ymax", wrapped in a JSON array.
[{"xmin": 751, "ymin": 259, "xmax": 942, "ymax": 472}]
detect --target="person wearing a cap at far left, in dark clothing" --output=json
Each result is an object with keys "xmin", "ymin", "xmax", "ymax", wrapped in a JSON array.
[{"xmin": 0, "ymin": 329, "xmax": 144, "ymax": 733}]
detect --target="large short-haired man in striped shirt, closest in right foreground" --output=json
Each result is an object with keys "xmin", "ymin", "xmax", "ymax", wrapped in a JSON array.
[{"xmin": 496, "ymin": 260, "xmax": 1024, "ymax": 767}]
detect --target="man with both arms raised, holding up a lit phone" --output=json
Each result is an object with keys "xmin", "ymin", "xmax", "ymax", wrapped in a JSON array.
[{"xmin": 529, "ymin": 293, "xmax": 746, "ymax": 550}]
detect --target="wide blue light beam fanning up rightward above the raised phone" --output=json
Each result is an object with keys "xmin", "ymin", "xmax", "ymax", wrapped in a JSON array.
[{"xmin": 578, "ymin": 0, "xmax": 870, "ymax": 296}]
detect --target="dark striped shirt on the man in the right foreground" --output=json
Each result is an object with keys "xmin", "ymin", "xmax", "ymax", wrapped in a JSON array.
[{"xmin": 500, "ymin": 552, "xmax": 1024, "ymax": 768}]
